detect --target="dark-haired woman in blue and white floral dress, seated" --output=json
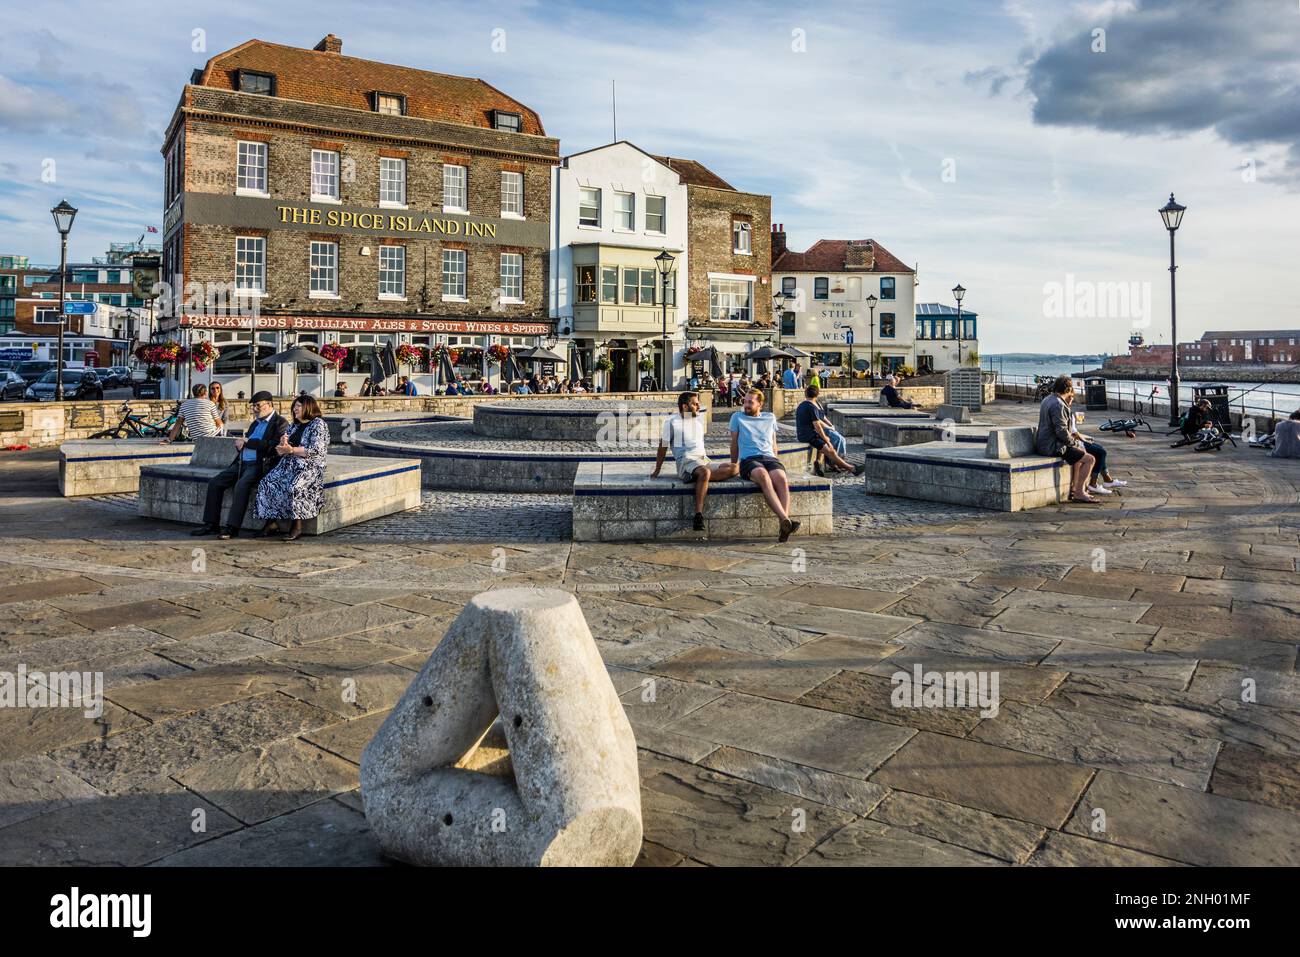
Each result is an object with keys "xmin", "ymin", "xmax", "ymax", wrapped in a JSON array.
[{"xmin": 256, "ymin": 395, "xmax": 329, "ymax": 542}]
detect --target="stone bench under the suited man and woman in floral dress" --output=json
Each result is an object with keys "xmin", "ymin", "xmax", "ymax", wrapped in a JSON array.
[{"xmin": 137, "ymin": 438, "xmax": 420, "ymax": 534}]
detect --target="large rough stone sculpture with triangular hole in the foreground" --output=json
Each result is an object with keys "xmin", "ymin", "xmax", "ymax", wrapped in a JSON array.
[{"xmin": 361, "ymin": 588, "xmax": 641, "ymax": 866}]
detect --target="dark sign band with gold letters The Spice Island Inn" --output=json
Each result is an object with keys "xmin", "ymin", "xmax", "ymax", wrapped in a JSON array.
[{"xmin": 176, "ymin": 192, "xmax": 547, "ymax": 248}]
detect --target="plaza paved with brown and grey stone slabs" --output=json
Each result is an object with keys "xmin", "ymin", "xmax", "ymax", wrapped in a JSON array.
[{"xmin": 0, "ymin": 402, "xmax": 1300, "ymax": 866}]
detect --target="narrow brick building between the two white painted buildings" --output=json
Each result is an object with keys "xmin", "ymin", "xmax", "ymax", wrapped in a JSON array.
[{"xmin": 681, "ymin": 162, "xmax": 775, "ymax": 371}]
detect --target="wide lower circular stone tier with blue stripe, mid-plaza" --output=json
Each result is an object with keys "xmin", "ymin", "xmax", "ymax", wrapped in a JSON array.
[{"xmin": 352, "ymin": 421, "xmax": 809, "ymax": 494}]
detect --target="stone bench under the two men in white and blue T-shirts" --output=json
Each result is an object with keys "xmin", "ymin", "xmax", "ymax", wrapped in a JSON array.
[{"xmin": 573, "ymin": 460, "xmax": 833, "ymax": 542}]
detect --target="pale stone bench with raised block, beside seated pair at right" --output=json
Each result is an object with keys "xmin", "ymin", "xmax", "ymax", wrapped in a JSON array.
[{"xmin": 863, "ymin": 428, "xmax": 1070, "ymax": 512}]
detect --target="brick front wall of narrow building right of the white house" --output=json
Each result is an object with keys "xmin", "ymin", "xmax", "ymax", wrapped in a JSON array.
[{"xmin": 686, "ymin": 186, "xmax": 772, "ymax": 326}]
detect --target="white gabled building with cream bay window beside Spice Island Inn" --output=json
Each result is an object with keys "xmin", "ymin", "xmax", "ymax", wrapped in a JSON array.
[{"xmin": 549, "ymin": 140, "xmax": 688, "ymax": 391}]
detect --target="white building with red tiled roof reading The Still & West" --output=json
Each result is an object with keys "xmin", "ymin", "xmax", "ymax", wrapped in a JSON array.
[{"xmin": 772, "ymin": 226, "xmax": 917, "ymax": 374}]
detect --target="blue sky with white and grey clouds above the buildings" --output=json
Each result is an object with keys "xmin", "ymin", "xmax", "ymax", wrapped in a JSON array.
[{"xmin": 0, "ymin": 0, "xmax": 1300, "ymax": 352}]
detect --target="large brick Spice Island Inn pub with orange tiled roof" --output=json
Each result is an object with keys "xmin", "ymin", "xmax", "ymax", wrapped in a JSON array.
[{"xmin": 156, "ymin": 34, "xmax": 559, "ymax": 398}]
